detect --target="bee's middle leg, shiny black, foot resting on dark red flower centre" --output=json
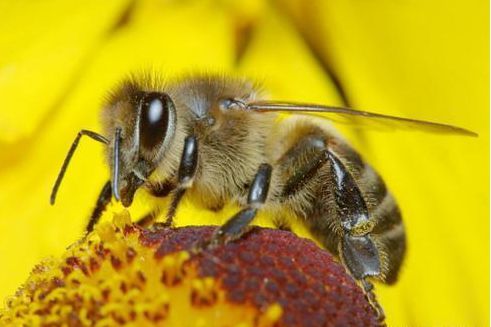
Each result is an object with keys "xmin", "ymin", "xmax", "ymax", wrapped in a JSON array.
[{"xmin": 207, "ymin": 164, "xmax": 272, "ymax": 246}]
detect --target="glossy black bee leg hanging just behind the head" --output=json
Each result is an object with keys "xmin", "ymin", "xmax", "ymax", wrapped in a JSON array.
[{"xmin": 164, "ymin": 135, "xmax": 198, "ymax": 226}]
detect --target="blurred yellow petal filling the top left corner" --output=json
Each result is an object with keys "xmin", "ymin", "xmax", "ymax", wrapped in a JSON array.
[{"xmin": 0, "ymin": 0, "xmax": 133, "ymax": 143}]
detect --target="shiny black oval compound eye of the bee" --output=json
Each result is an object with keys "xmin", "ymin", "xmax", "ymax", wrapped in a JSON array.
[{"xmin": 140, "ymin": 93, "xmax": 173, "ymax": 150}]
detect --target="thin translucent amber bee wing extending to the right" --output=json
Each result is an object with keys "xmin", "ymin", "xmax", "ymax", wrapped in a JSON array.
[{"xmin": 247, "ymin": 101, "xmax": 478, "ymax": 137}]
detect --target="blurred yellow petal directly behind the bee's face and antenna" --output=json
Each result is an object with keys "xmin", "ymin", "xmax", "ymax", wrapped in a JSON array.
[{"xmin": 0, "ymin": 3, "xmax": 233, "ymax": 297}]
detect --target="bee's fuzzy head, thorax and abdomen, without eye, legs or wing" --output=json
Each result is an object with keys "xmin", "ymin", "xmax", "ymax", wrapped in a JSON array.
[{"xmin": 99, "ymin": 76, "xmax": 405, "ymax": 282}]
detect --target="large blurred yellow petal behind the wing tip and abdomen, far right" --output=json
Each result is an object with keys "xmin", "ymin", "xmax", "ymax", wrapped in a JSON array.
[{"xmin": 282, "ymin": 1, "xmax": 489, "ymax": 326}]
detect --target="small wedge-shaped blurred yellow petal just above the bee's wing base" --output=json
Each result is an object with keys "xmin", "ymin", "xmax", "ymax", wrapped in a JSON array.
[{"xmin": 239, "ymin": 2, "xmax": 340, "ymax": 105}]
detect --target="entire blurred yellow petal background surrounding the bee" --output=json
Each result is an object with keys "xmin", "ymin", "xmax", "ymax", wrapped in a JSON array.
[{"xmin": 0, "ymin": 0, "xmax": 489, "ymax": 326}]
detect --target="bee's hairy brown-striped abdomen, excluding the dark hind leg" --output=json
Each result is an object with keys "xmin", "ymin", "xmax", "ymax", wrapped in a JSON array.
[{"xmin": 270, "ymin": 117, "xmax": 406, "ymax": 283}]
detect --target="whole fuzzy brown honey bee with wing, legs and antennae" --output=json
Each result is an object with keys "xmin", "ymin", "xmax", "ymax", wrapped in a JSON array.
[{"xmin": 51, "ymin": 75, "xmax": 475, "ymax": 320}]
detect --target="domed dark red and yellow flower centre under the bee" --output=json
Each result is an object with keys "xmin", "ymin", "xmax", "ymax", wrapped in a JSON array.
[{"xmin": 0, "ymin": 211, "xmax": 379, "ymax": 327}]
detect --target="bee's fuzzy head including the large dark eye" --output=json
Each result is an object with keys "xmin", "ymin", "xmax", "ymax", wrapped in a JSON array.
[{"xmin": 104, "ymin": 85, "xmax": 176, "ymax": 206}]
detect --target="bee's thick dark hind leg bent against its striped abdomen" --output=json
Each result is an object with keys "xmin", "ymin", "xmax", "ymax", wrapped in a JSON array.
[{"xmin": 281, "ymin": 140, "xmax": 385, "ymax": 325}]
